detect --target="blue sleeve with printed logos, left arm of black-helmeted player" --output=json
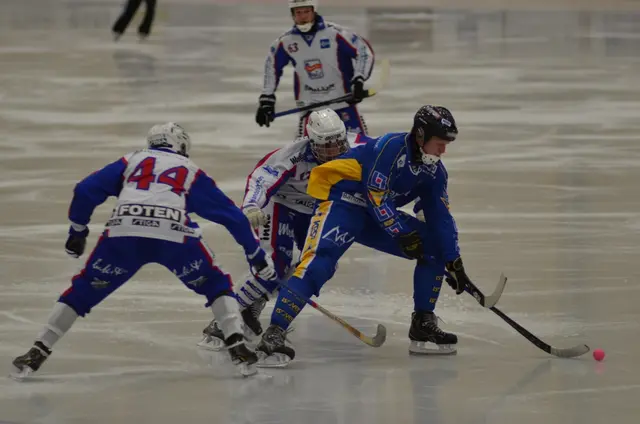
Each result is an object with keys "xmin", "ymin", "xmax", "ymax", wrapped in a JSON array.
[{"xmin": 363, "ymin": 136, "xmax": 412, "ymax": 237}]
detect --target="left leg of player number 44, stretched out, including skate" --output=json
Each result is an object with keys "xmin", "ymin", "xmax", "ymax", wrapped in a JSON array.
[{"xmin": 13, "ymin": 237, "xmax": 145, "ymax": 378}]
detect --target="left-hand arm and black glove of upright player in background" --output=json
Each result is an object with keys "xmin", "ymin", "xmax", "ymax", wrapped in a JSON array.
[{"xmin": 256, "ymin": 38, "xmax": 291, "ymax": 127}]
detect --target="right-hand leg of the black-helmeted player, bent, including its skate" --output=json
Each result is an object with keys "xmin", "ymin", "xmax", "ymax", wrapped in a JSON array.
[{"xmin": 357, "ymin": 212, "xmax": 458, "ymax": 355}]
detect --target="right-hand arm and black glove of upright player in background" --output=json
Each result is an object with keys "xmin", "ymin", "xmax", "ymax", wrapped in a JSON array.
[{"xmin": 337, "ymin": 29, "xmax": 375, "ymax": 102}]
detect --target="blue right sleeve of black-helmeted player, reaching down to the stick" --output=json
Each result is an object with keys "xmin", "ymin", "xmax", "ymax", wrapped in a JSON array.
[{"xmin": 414, "ymin": 163, "xmax": 460, "ymax": 262}]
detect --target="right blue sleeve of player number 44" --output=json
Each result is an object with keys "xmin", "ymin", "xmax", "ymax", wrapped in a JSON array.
[{"xmin": 186, "ymin": 171, "xmax": 259, "ymax": 256}]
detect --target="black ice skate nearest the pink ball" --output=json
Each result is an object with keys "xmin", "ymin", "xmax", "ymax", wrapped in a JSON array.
[{"xmin": 409, "ymin": 312, "xmax": 458, "ymax": 355}]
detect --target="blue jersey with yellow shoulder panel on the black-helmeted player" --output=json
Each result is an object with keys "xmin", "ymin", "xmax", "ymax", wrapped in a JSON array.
[{"xmin": 307, "ymin": 133, "xmax": 460, "ymax": 261}]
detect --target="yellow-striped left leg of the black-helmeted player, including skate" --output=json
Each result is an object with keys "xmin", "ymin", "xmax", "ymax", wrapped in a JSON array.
[{"xmin": 256, "ymin": 201, "xmax": 366, "ymax": 366}]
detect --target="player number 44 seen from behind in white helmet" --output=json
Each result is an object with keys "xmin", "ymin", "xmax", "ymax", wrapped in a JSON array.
[{"xmin": 13, "ymin": 123, "xmax": 275, "ymax": 377}]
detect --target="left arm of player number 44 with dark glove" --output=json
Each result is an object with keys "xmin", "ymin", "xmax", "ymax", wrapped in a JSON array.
[{"xmin": 65, "ymin": 158, "xmax": 127, "ymax": 258}]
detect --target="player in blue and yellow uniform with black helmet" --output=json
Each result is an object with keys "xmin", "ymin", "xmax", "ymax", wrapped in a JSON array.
[{"xmin": 245, "ymin": 106, "xmax": 480, "ymax": 366}]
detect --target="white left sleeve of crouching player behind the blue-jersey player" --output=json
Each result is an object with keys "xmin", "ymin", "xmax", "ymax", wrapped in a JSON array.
[{"xmin": 242, "ymin": 140, "xmax": 307, "ymax": 208}]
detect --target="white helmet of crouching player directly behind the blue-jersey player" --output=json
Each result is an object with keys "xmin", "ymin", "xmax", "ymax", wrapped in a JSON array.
[{"xmin": 307, "ymin": 109, "xmax": 349, "ymax": 162}]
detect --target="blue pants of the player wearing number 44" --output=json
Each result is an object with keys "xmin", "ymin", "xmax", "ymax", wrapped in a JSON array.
[{"xmin": 59, "ymin": 235, "xmax": 232, "ymax": 316}]
